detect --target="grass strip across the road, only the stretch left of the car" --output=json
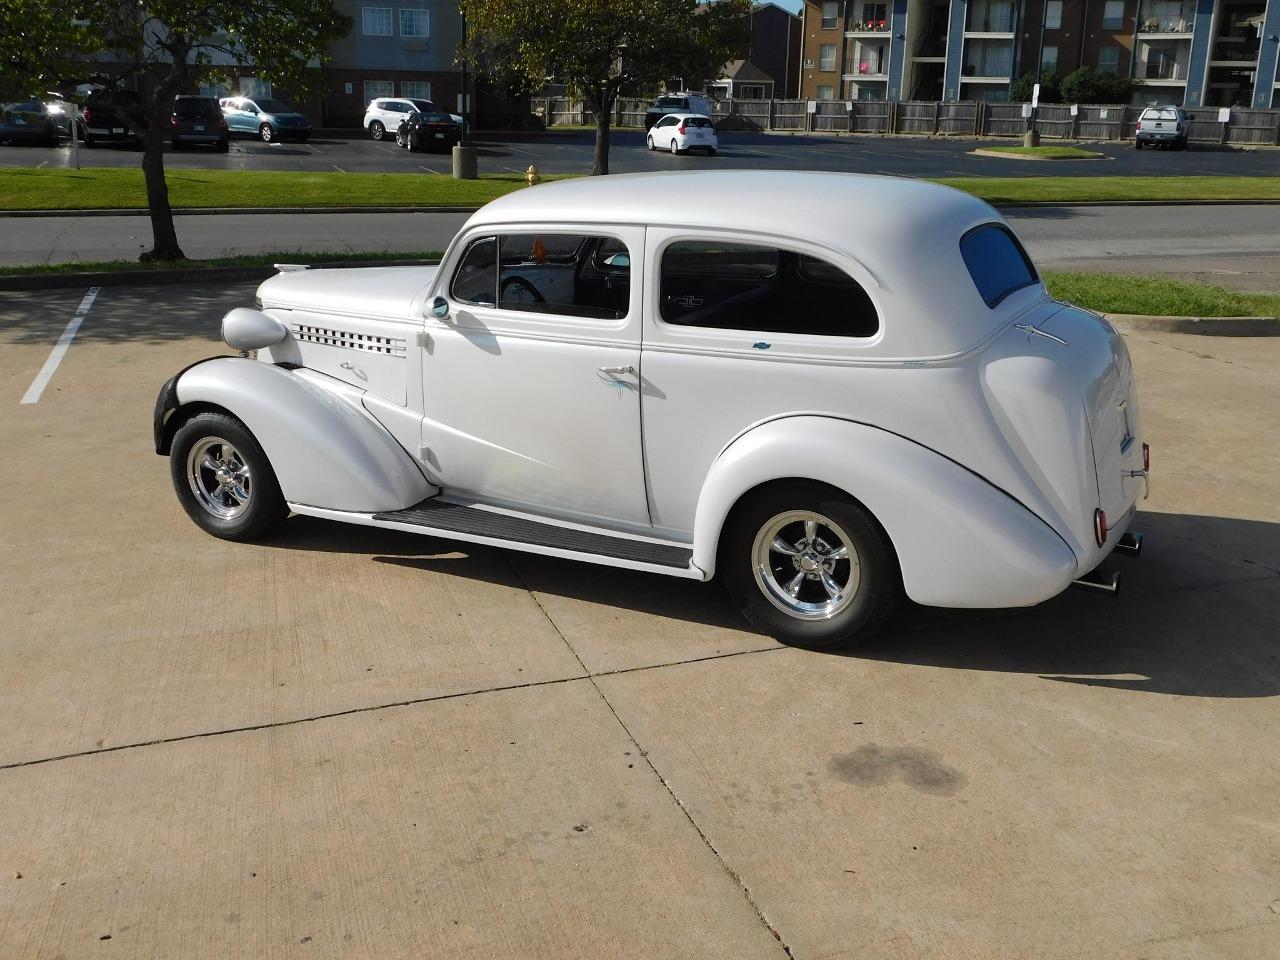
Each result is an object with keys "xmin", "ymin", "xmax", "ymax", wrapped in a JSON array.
[{"xmin": 0, "ymin": 168, "xmax": 556, "ymax": 210}]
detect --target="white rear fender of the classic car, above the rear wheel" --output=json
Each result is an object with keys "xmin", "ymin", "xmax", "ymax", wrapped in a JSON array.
[{"xmin": 694, "ymin": 416, "xmax": 1076, "ymax": 607}]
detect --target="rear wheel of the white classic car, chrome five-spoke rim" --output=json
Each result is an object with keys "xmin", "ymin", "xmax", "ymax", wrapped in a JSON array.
[{"xmin": 719, "ymin": 480, "xmax": 901, "ymax": 649}]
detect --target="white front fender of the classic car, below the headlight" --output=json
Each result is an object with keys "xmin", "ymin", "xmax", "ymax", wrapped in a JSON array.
[{"xmin": 177, "ymin": 357, "xmax": 435, "ymax": 513}]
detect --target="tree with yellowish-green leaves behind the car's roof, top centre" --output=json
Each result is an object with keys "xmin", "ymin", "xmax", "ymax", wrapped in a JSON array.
[{"xmin": 462, "ymin": 0, "xmax": 751, "ymax": 175}]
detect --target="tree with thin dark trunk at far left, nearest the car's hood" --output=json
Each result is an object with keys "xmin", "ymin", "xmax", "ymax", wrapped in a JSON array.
[{"xmin": 0, "ymin": 0, "xmax": 351, "ymax": 260}]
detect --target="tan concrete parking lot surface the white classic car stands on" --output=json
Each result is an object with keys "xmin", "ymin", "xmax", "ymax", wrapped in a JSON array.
[{"xmin": 0, "ymin": 281, "xmax": 1280, "ymax": 960}]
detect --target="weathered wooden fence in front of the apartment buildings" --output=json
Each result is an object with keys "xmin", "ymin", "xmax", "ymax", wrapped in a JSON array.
[{"xmin": 530, "ymin": 97, "xmax": 1280, "ymax": 145}]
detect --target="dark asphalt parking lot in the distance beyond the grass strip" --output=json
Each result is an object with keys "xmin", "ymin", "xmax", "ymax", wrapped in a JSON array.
[{"xmin": 10, "ymin": 129, "xmax": 1280, "ymax": 177}]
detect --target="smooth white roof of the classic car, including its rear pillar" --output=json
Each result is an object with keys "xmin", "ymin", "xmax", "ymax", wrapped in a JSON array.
[{"xmin": 465, "ymin": 170, "xmax": 1044, "ymax": 358}]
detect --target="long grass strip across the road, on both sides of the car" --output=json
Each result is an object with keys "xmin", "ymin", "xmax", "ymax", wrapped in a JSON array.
[{"xmin": 0, "ymin": 166, "xmax": 1280, "ymax": 210}]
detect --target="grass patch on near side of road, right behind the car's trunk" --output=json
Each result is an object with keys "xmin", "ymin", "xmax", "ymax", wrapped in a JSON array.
[{"xmin": 1044, "ymin": 271, "xmax": 1280, "ymax": 316}]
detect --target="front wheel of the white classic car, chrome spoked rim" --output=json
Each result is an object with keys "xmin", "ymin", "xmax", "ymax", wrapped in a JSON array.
[{"xmin": 169, "ymin": 413, "xmax": 289, "ymax": 540}]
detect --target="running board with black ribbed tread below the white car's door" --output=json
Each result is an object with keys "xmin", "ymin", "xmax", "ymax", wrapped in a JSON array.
[{"xmin": 289, "ymin": 498, "xmax": 705, "ymax": 580}]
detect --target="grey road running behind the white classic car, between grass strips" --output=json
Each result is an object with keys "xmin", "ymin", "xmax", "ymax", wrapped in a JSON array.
[{"xmin": 0, "ymin": 205, "xmax": 1280, "ymax": 289}]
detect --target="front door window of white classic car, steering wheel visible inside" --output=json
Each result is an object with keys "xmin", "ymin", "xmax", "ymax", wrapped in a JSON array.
[{"xmin": 452, "ymin": 233, "xmax": 631, "ymax": 320}]
